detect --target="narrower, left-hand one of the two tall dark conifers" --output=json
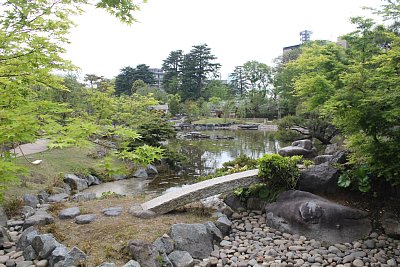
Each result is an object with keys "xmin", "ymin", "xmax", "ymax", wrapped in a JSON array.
[{"xmin": 162, "ymin": 50, "xmax": 183, "ymax": 94}]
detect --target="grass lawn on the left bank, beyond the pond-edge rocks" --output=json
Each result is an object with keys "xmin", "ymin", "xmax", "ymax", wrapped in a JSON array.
[{"xmin": 5, "ymin": 147, "xmax": 100, "ymax": 197}]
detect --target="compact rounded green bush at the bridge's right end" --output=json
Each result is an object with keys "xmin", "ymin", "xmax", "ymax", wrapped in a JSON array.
[{"xmin": 258, "ymin": 154, "xmax": 301, "ymax": 190}]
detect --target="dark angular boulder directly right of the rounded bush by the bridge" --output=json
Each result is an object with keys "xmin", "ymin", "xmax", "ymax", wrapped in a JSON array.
[{"xmin": 298, "ymin": 162, "xmax": 340, "ymax": 193}]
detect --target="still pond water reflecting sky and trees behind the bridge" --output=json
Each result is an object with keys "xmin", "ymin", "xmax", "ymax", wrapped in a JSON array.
[{"xmin": 87, "ymin": 130, "xmax": 284, "ymax": 196}]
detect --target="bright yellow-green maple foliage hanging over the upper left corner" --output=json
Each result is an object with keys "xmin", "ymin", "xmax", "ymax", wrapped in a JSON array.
[{"xmin": 0, "ymin": 0, "xmax": 144, "ymax": 199}]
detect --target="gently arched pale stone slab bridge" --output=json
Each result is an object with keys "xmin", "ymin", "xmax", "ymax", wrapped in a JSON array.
[{"xmin": 141, "ymin": 170, "xmax": 261, "ymax": 214}]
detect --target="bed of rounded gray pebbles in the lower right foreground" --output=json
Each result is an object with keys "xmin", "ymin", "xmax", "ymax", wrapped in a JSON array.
[{"xmin": 202, "ymin": 211, "xmax": 400, "ymax": 267}]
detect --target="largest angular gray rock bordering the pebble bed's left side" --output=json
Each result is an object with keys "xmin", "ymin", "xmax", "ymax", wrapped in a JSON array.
[{"xmin": 170, "ymin": 224, "xmax": 213, "ymax": 259}]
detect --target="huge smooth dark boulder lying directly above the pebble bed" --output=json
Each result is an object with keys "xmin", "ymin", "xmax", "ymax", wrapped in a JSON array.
[{"xmin": 266, "ymin": 190, "xmax": 371, "ymax": 244}]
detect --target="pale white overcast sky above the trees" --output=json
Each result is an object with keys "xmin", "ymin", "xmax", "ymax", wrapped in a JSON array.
[{"xmin": 66, "ymin": 0, "xmax": 381, "ymax": 79}]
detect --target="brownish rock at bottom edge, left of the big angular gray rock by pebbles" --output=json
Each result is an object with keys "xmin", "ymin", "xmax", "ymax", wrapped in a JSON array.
[{"xmin": 128, "ymin": 240, "xmax": 161, "ymax": 267}]
